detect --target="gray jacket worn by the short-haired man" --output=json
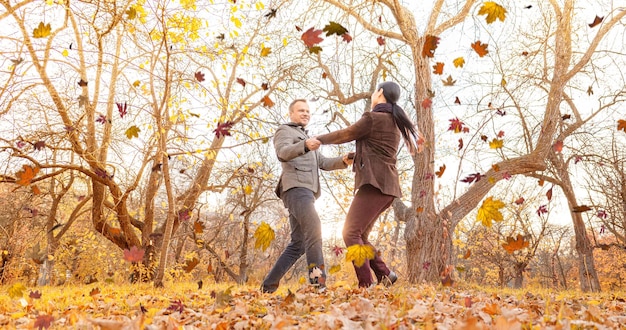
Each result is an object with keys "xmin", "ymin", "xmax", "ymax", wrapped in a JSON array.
[{"xmin": 274, "ymin": 123, "xmax": 348, "ymax": 198}]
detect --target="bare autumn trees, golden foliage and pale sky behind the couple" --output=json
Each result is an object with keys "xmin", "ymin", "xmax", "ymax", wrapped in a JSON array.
[{"xmin": 0, "ymin": 0, "xmax": 626, "ymax": 322}]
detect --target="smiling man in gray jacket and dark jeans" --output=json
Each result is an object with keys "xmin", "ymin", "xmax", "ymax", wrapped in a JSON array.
[{"xmin": 261, "ymin": 99, "xmax": 352, "ymax": 293}]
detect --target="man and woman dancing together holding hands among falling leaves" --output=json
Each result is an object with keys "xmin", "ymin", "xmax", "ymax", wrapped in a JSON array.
[{"xmin": 261, "ymin": 81, "xmax": 423, "ymax": 293}]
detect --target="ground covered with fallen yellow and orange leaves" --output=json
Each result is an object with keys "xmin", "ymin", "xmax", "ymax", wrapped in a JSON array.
[{"xmin": 0, "ymin": 283, "xmax": 626, "ymax": 329}]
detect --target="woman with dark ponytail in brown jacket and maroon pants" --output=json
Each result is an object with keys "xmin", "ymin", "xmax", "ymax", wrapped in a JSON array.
[{"xmin": 317, "ymin": 81, "xmax": 416, "ymax": 287}]
